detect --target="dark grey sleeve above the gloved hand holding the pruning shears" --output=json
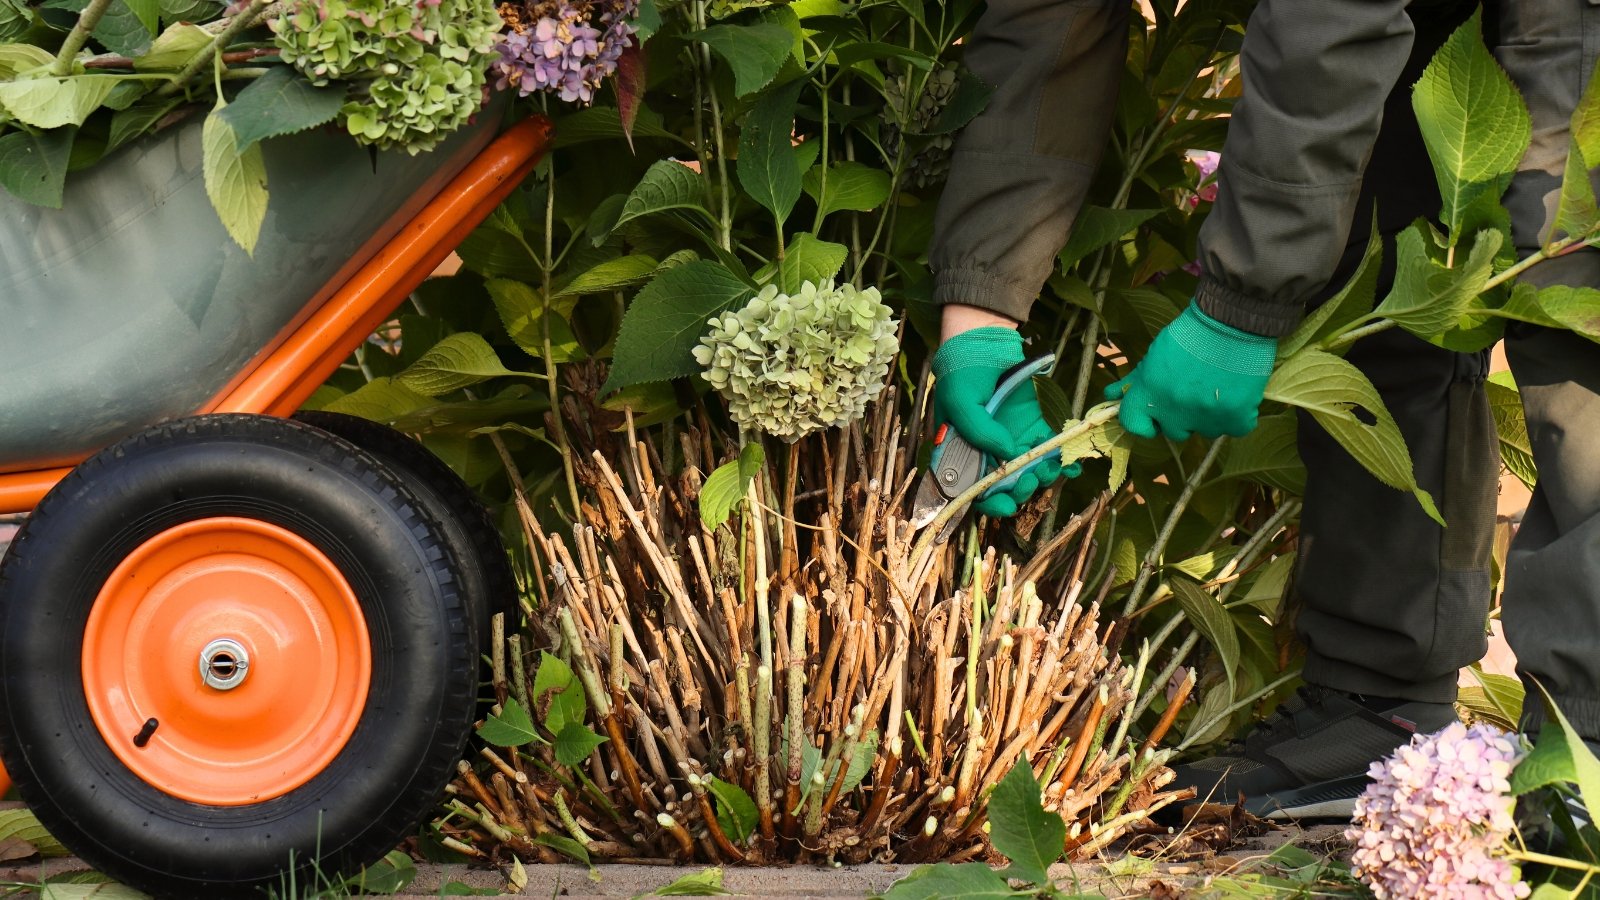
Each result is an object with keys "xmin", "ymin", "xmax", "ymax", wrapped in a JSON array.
[{"xmin": 928, "ymin": 0, "xmax": 1130, "ymax": 320}]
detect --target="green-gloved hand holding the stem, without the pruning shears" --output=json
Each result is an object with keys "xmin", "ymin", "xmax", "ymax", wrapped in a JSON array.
[{"xmin": 1106, "ymin": 303, "xmax": 1278, "ymax": 440}]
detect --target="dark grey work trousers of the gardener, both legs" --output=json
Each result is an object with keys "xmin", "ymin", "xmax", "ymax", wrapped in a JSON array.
[{"xmin": 1296, "ymin": 0, "xmax": 1600, "ymax": 738}]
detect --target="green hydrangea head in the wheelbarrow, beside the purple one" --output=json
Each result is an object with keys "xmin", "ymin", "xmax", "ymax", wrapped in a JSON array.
[{"xmin": 272, "ymin": 0, "xmax": 501, "ymax": 154}]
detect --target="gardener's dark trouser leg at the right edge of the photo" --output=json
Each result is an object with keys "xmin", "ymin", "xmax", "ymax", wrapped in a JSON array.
[{"xmin": 1496, "ymin": 0, "xmax": 1600, "ymax": 738}]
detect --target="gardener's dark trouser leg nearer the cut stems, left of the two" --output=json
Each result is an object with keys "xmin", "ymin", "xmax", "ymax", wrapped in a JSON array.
[{"xmin": 1294, "ymin": 3, "xmax": 1498, "ymax": 701}]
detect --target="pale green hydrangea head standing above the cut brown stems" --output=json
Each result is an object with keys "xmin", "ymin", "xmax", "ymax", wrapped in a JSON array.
[{"xmin": 694, "ymin": 282, "xmax": 899, "ymax": 444}]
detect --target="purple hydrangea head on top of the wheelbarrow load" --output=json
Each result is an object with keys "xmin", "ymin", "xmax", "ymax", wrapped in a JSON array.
[{"xmin": 494, "ymin": 0, "xmax": 638, "ymax": 104}]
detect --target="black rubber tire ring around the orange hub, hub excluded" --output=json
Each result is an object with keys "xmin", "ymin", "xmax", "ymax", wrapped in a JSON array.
[{"xmin": 0, "ymin": 415, "xmax": 477, "ymax": 897}]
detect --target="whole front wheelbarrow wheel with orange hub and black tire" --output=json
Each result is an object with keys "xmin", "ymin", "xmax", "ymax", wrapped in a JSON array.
[{"xmin": 0, "ymin": 415, "xmax": 477, "ymax": 897}]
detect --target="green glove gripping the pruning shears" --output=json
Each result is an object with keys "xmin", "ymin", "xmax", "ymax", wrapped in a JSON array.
[{"xmin": 933, "ymin": 325, "xmax": 1080, "ymax": 516}]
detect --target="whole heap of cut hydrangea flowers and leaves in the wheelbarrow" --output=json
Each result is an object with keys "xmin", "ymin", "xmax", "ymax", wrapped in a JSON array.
[{"xmin": 0, "ymin": 0, "xmax": 637, "ymax": 251}]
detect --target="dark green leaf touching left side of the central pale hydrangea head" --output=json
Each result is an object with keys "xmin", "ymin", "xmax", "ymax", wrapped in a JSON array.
[{"xmin": 602, "ymin": 259, "xmax": 752, "ymax": 394}]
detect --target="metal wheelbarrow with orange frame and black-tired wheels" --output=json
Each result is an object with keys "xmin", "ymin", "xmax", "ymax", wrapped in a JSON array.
[{"xmin": 0, "ymin": 106, "xmax": 549, "ymax": 897}]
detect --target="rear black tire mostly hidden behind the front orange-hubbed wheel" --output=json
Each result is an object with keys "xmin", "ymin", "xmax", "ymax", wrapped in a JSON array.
[{"xmin": 294, "ymin": 410, "xmax": 518, "ymax": 649}]
